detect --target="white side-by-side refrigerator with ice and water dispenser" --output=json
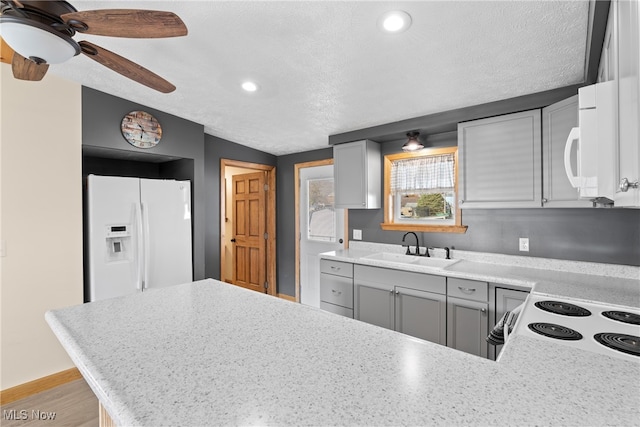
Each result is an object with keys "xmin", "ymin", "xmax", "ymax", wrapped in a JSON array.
[{"xmin": 87, "ymin": 175, "xmax": 193, "ymax": 301}]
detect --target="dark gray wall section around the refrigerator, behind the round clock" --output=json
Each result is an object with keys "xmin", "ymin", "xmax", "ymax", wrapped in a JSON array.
[{"xmin": 82, "ymin": 87, "xmax": 205, "ymax": 279}]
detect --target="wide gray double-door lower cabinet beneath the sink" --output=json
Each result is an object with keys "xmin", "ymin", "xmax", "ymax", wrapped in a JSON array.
[{"xmin": 353, "ymin": 265, "xmax": 447, "ymax": 345}]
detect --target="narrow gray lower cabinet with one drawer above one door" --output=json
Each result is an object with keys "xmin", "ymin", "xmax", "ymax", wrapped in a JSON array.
[{"xmin": 447, "ymin": 278, "xmax": 489, "ymax": 358}]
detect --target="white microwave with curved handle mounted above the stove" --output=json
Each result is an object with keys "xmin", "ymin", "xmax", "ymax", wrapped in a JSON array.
[{"xmin": 564, "ymin": 81, "xmax": 617, "ymax": 200}]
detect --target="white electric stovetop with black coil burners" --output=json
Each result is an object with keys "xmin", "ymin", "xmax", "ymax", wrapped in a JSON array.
[{"xmin": 514, "ymin": 292, "xmax": 640, "ymax": 363}]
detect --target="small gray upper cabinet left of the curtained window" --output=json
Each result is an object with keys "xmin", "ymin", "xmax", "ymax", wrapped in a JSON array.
[{"xmin": 333, "ymin": 140, "xmax": 382, "ymax": 209}]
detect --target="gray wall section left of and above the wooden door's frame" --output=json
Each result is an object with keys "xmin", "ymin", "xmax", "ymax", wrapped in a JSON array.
[{"xmin": 204, "ymin": 135, "xmax": 280, "ymax": 279}]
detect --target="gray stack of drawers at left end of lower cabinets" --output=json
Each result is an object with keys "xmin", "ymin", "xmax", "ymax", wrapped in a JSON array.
[{"xmin": 320, "ymin": 259, "xmax": 353, "ymax": 318}]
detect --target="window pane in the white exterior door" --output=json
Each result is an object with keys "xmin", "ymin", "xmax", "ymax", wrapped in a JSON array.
[{"xmin": 307, "ymin": 178, "xmax": 336, "ymax": 242}]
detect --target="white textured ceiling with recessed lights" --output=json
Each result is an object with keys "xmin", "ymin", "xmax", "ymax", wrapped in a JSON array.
[{"xmin": 42, "ymin": 0, "xmax": 589, "ymax": 155}]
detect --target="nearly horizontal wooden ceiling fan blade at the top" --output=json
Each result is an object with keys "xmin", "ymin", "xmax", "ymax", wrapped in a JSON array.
[{"xmin": 60, "ymin": 9, "xmax": 187, "ymax": 39}]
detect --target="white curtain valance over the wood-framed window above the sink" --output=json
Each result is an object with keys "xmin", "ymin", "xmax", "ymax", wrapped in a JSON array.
[{"xmin": 391, "ymin": 154, "xmax": 455, "ymax": 194}]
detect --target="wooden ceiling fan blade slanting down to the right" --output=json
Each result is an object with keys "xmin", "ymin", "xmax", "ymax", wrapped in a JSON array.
[{"xmin": 78, "ymin": 40, "xmax": 176, "ymax": 93}]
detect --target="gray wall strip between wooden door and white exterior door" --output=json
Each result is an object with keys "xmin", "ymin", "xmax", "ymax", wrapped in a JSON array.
[{"xmin": 276, "ymin": 148, "xmax": 333, "ymax": 296}]
